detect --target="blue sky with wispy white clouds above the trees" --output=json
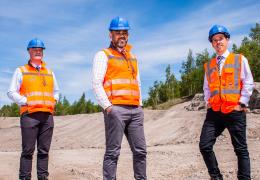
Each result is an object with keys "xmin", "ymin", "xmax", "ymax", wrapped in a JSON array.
[{"xmin": 0, "ymin": 0, "xmax": 260, "ymax": 106}]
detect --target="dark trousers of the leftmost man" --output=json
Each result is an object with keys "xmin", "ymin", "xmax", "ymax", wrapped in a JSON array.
[{"xmin": 19, "ymin": 112, "xmax": 54, "ymax": 179}]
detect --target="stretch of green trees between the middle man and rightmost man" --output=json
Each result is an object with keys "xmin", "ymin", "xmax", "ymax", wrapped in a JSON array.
[{"xmin": 144, "ymin": 50, "xmax": 212, "ymax": 108}]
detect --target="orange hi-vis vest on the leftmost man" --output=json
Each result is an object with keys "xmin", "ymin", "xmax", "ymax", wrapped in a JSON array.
[{"xmin": 20, "ymin": 63, "xmax": 55, "ymax": 114}]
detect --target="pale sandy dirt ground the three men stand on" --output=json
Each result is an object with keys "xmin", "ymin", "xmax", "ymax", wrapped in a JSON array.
[{"xmin": 0, "ymin": 102, "xmax": 260, "ymax": 180}]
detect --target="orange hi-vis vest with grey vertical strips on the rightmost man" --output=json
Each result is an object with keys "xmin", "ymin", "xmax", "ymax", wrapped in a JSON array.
[{"xmin": 204, "ymin": 53, "xmax": 243, "ymax": 114}]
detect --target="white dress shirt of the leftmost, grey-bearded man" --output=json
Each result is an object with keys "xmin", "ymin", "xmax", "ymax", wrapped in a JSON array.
[{"xmin": 7, "ymin": 64, "xmax": 60, "ymax": 106}]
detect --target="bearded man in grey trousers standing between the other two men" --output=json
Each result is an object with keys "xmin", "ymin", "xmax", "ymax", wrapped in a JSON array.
[{"xmin": 92, "ymin": 17, "xmax": 147, "ymax": 180}]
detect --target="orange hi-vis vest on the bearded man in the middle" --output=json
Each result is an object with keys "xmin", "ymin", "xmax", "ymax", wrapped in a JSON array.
[{"xmin": 103, "ymin": 46, "xmax": 140, "ymax": 105}]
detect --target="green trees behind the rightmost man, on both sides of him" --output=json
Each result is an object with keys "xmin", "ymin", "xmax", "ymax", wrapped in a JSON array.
[{"xmin": 144, "ymin": 23, "xmax": 260, "ymax": 108}]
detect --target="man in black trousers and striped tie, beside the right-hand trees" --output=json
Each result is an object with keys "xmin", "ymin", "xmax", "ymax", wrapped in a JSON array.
[{"xmin": 199, "ymin": 25, "xmax": 254, "ymax": 180}]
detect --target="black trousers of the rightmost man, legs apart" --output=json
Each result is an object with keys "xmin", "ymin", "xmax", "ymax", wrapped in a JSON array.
[{"xmin": 199, "ymin": 109, "xmax": 251, "ymax": 180}]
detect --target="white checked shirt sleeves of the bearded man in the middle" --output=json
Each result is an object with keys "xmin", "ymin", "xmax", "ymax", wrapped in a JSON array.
[{"xmin": 92, "ymin": 51, "xmax": 142, "ymax": 109}]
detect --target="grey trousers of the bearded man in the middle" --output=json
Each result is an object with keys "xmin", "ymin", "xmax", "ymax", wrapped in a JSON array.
[{"xmin": 103, "ymin": 105, "xmax": 147, "ymax": 180}]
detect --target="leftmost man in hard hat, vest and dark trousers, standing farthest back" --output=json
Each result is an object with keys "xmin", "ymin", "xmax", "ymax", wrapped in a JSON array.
[{"xmin": 7, "ymin": 39, "xmax": 59, "ymax": 180}]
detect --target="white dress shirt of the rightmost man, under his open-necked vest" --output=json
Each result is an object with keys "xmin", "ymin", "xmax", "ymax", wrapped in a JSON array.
[{"xmin": 203, "ymin": 50, "xmax": 254, "ymax": 106}]
